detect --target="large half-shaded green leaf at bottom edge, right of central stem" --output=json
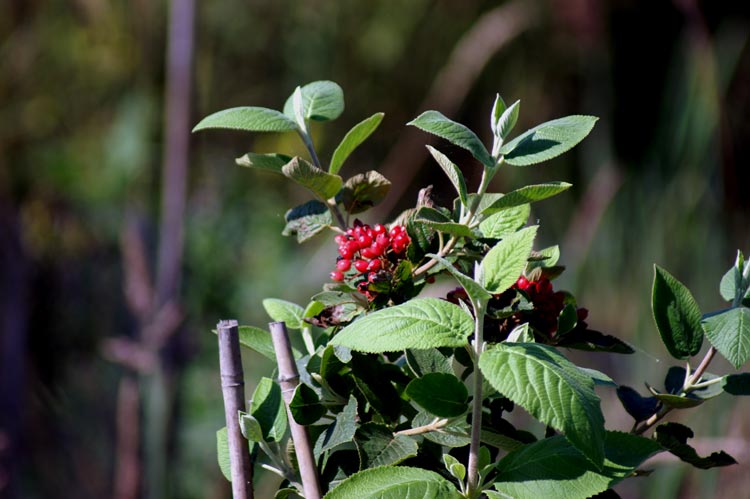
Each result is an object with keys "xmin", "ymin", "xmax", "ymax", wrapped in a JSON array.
[{"xmin": 488, "ymin": 431, "xmax": 662, "ymax": 499}]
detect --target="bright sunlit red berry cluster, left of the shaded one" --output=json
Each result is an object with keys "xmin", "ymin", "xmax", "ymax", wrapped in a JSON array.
[{"xmin": 330, "ymin": 220, "xmax": 411, "ymax": 299}]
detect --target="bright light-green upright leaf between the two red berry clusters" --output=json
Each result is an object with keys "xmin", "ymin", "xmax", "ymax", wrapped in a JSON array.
[{"xmin": 480, "ymin": 225, "xmax": 538, "ymax": 293}]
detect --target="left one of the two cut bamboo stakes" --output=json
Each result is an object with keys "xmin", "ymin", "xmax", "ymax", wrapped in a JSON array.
[{"xmin": 216, "ymin": 320, "xmax": 253, "ymax": 499}]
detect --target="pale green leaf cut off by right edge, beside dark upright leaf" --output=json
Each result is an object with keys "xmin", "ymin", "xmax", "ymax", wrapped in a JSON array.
[{"xmin": 703, "ymin": 307, "xmax": 750, "ymax": 369}]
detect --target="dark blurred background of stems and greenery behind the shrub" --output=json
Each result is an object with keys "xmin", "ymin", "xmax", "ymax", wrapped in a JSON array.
[{"xmin": 0, "ymin": 0, "xmax": 750, "ymax": 499}]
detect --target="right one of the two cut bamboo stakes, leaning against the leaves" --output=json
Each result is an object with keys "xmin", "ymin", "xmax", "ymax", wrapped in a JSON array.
[{"xmin": 268, "ymin": 322, "xmax": 321, "ymax": 499}]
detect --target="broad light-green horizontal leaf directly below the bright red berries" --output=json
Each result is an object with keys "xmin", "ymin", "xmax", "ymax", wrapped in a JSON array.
[{"xmin": 329, "ymin": 298, "xmax": 474, "ymax": 353}]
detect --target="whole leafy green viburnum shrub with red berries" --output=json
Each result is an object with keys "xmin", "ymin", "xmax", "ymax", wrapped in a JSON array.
[{"xmin": 195, "ymin": 81, "xmax": 750, "ymax": 499}]
